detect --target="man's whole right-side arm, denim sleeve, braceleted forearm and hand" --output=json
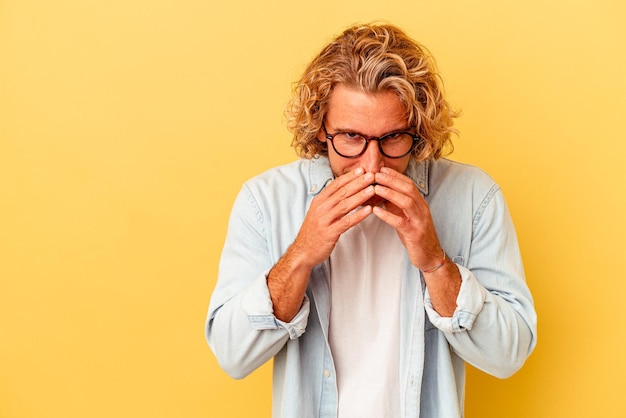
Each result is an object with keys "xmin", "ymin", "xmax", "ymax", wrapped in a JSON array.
[{"xmin": 374, "ymin": 168, "xmax": 536, "ymax": 377}]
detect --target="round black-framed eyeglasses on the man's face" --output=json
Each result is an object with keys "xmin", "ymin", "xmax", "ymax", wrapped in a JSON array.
[{"xmin": 322, "ymin": 122, "xmax": 422, "ymax": 158}]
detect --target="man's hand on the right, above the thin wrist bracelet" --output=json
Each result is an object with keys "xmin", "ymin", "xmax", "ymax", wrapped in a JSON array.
[{"xmin": 374, "ymin": 167, "xmax": 442, "ymax": 270}]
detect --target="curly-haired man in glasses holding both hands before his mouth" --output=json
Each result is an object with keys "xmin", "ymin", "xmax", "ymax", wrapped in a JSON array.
[{"xmin": 206, "ymin": 25, "xmax": 536, "ymax": 418}]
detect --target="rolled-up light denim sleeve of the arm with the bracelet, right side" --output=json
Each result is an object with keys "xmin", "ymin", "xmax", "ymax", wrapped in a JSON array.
[{"xmin": 425, "ymin": 186, "xmax": 537, "ymax": 378}]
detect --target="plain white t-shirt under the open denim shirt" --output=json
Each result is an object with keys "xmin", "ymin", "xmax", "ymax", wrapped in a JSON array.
[{"xmin": 329, "ymin": 215, "xmax": 404, "ymax": 418}]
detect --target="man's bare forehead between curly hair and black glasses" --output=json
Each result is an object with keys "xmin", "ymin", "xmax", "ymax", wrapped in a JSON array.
[{"xmin": 326, "ymin": 84, "xmax": 407, "ymax": 135}]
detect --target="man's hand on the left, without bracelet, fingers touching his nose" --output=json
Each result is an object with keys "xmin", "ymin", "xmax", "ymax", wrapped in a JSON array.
[{"xmin": 292, "ymin": 168, "xmax": 374, "ymax": 268}]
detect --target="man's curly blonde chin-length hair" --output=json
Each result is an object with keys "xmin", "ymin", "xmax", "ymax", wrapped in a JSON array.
[{"xmin": 285, "ymin": 24, "xmax": 458, "ymax": 161}]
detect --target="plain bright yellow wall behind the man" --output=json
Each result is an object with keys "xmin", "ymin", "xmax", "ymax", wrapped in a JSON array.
[{"xmin": 0, "ymin": 0, "xmax": 626, "ymax": 418}]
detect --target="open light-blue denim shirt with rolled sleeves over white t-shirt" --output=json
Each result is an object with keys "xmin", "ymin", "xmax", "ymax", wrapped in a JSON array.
[{"xmin": 205, "ymin": 157, "xmax": 537, "ymax": 418}]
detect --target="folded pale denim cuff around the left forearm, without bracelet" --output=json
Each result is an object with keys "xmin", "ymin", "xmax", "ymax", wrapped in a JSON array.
[{"xmin": 242, "ymin": 272, "xmax": 310, "ymax": 340}]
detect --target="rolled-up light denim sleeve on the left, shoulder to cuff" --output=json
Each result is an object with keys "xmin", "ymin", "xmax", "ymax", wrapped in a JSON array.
[{"xmin": 205, "ymin": 186, "xmax": 310, "ymax": 378}]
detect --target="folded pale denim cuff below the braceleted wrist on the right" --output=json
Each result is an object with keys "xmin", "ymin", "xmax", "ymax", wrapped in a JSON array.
[{"xmin": 424, "ymin": 264, "xmax": 487, "ymax": 333}]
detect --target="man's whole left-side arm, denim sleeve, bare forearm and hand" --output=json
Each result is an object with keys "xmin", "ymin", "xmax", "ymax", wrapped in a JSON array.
[{"xmin": 206, "ymin": 169, "xmax": 373, "ymax": 377}]
